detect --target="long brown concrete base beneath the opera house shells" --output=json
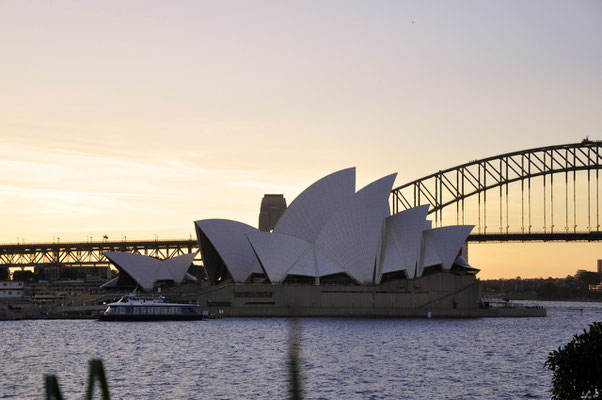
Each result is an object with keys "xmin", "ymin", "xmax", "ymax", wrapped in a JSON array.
[{"xmin": 185, "ymin": 272, "xmax": 546, "ymax": 318}]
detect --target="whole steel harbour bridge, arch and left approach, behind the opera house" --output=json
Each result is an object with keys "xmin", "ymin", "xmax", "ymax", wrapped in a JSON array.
[{"xmin": 0, "ymin": 139, "xmax": 602, "ymax": 268}]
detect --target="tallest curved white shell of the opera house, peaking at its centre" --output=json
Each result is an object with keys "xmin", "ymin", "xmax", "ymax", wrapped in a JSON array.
[{"xmin": 274, "ymin": 168, "xmax": 355, "ymax": 243}]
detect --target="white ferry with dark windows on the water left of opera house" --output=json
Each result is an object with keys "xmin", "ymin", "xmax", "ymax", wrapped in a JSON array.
[{"xmin": 99, "ymin": 293, "xmax": 204, "ymax": 321}]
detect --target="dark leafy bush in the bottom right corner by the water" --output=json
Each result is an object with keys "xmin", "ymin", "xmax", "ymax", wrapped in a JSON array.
[{"xmin": 545, "ymin": 322, "xmax": 602, "ymax": 400}]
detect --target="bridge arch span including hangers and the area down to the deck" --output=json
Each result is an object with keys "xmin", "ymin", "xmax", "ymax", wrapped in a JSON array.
[{"xmin": 391, "ymin": 139, "xmax": 602, "ymax": 241}]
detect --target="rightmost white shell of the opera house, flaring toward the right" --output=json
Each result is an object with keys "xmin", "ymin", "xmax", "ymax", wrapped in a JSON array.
[{"xmin": 423, "ymin": 225, "xmax": 474, "ymax": 271}]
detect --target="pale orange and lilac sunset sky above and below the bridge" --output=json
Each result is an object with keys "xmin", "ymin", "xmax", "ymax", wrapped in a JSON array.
[{"xmin": 0, "ymin": 0, "xmax": 602, "ymax": 278}]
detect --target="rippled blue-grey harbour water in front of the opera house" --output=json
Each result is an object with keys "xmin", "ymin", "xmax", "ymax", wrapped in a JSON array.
[{"xmin": 0, "ymin": 302, "xmax": 602, "ymax": 399}]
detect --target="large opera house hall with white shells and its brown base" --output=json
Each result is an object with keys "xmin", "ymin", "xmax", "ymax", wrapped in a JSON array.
[{"xmin": 195, "ymin": 168, "xmax": 488, "ymax": 316}]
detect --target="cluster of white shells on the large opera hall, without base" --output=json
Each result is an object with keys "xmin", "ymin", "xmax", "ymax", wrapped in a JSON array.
[{"xmin": 195, "ymin": 168, "xmax": 476, "ymax": 286}]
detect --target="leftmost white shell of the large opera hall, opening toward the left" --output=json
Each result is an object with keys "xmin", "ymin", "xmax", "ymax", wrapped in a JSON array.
[{"xmin": 195, "ymin": 219, "xmax": 263, "ymax": 282}]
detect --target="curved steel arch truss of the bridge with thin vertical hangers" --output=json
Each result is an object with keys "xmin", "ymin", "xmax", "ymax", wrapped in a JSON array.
[{"xmin": 391, "ymin": 139, "xmax": 602, "ymax": 234}]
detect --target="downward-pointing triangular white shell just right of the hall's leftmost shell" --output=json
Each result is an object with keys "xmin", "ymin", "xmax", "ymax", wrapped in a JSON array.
[{"xmin": 247, "ymin": 231, "xmax": 312, "ymax": 283}]
